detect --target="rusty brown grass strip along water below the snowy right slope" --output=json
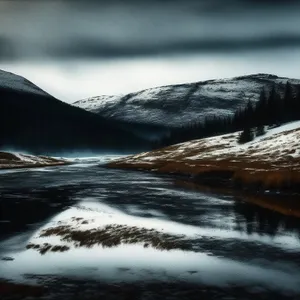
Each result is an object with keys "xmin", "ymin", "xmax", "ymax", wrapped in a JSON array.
[{"xmin": 105, "ymin": 159, "xmax": 300, "ymax": 195}]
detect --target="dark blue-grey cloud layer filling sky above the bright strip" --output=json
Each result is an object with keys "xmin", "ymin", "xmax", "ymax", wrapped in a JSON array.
[{"xmin": 0, "ymin": 0, "xmax": 300, "ymax": 59}]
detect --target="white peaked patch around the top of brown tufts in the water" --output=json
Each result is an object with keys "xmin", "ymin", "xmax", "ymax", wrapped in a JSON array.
[{"xmin": 24, "ymin": 199, "xmax": 299, "ymax": 251}]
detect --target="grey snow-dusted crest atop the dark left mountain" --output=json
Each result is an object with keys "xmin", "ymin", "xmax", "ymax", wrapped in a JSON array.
[{"xmin": 0, "ymin": 70, "xmax": 50, "ymax": 97}]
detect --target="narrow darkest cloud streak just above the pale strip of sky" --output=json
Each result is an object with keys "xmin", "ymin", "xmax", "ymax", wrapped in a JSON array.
[{"xmin": 50, "ymin": 35, "xmax": 300, "ymax": 58}]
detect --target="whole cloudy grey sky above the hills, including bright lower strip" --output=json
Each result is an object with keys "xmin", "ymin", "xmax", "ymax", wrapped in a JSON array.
[{"xmin": 0, "ymin": 0, "xmax": 300, "ymax": 103}]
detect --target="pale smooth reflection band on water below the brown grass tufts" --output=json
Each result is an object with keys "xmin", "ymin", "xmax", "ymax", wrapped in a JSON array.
[{"xmin": 2, "ymin": 245, "xmax": 300, "ymax": 293}]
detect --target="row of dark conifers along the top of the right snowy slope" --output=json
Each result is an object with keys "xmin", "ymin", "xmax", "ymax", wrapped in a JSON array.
[{"xmin": 155, "ymin": 82, "xmax": 300, "ymax": 147}]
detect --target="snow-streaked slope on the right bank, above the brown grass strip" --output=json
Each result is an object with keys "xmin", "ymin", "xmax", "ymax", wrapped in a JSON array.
[{"xmin": 112, "ymin": 121, "xmax": 300, "ymax": 174}]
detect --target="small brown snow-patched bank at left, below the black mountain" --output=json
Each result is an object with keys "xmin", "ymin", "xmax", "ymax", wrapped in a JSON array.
[{"xmin": 0, "ymin": 152, "xmax": 71, "ymax": 170}]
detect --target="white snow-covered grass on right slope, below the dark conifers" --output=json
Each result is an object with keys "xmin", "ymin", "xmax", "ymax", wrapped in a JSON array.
[{"xmin": 109, "ymin": 121, "xmax": 300, "ymax": 171}]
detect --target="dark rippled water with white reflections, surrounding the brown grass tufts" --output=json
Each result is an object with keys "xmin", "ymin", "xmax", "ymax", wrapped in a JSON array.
[{"xmin": 0, "ymin": 161, "xmax": 300, "ymax": 299}]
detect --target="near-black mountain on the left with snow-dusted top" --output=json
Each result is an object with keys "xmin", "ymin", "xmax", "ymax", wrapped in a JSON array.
[{"xmin": 0, "ymin": 70, "xmax": 150, "ymax": 154}]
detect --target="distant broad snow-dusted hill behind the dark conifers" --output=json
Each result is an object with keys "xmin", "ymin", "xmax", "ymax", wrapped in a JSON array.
[{"xmin": 74, "ymin": 74, "xmax": 300, "ymax": 127}]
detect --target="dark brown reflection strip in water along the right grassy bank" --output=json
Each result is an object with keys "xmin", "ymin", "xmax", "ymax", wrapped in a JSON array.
[{"xmin": 105, "ymin": 162, "xmax": 300, "ymax": 218}]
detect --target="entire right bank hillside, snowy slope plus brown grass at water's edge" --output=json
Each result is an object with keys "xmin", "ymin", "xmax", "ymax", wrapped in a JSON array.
[{"xmin": 108, "ymin": 121, "xmax": 300, "ymax": 191}]
